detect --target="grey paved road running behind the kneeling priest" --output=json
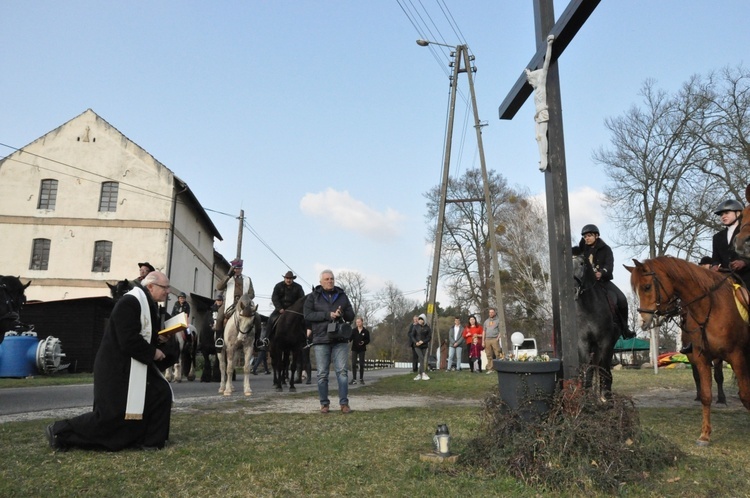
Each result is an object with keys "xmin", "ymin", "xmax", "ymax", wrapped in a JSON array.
[{"xmin": 0, "ymin": 368, "xmax": 411, "ymax": 423}]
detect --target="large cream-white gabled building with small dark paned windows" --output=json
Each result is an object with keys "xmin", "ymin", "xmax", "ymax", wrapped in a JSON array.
[{"xmin": 0, "ymin": 109, "xmax": 228, "ymax": 309}]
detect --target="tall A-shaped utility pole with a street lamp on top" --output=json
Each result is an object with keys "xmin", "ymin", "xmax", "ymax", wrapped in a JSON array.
[{"xmin": 417, "ymin": 40, "xmax": 507, "ymax": 363}]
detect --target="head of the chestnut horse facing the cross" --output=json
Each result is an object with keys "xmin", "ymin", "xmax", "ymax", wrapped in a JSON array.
[{"xmin": 623, "ymin": 259, "xmax": 674, "ymax": 330}]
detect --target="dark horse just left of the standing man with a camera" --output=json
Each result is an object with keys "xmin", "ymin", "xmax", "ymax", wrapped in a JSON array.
[{"xmin": 260, "ymin": 296, "xmax": 307, "ymax": 392}]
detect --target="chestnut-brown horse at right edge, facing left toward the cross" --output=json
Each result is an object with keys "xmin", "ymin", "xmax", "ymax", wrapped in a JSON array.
[{"xmin": 625, "ymin": 256, "xmax": 750, "ymax": 446}]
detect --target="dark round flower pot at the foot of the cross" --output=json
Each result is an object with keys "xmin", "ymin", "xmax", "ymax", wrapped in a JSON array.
[{"xmin": 492, "ymin": 358, "xmax": 560, "ymax": 421}]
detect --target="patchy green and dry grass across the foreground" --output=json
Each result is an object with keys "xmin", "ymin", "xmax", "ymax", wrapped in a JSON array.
[{"xmin": 0, "ymin": 371, "xmax": 750, "ymax": 497}]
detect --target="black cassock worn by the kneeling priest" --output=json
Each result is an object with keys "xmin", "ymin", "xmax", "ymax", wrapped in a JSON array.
[{"xmin": 52, "ymin": 290, "xmax": 174, "ymax": 451}]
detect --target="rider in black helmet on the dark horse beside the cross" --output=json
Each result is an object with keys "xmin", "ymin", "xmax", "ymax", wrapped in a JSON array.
[{"xmin": 578, "ymin": 224, "xmax": 635, "ymax": 339}]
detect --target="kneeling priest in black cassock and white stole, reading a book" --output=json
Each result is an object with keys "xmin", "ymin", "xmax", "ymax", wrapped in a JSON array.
[{"xmin": 45, "ymin": 271, "xmax": 176, "ymax": 451}]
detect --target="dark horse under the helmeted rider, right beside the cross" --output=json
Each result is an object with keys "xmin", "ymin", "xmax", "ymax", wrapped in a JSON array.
[{"xmin": 573, "ymin": 247, "xmax": 620, "ymax": 395}]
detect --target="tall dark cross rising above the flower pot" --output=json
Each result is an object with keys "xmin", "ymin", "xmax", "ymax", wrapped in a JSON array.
[{"xmin": 499, "ymin": 0, "xmax": 600, "ymax": 379}]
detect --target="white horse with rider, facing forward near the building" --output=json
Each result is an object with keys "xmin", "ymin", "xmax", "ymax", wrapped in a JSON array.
[{"xmin": 219, "ymin": 294, "xmax": 260, "ymax": 396}]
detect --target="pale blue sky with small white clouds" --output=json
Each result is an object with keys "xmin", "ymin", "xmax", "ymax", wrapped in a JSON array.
[{"xmin": 0, "ymin": 0, "xmax": 750, "ymax": 311}]
